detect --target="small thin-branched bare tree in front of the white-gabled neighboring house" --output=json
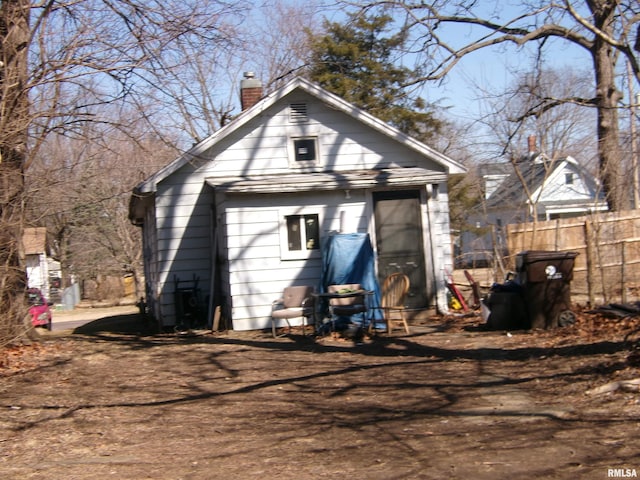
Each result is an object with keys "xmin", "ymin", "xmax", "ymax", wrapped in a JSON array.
[{"xmin": 482, "ymin": 69, "xmax": 604, "ymax": 255}]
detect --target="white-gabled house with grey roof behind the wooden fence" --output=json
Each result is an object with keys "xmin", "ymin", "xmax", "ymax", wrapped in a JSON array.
[{"xmin": 460, "ymin": 136, "xmax": 607, "ymax": 264}]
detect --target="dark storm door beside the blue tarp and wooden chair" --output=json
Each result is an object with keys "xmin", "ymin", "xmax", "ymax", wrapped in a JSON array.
[{"xmin": 373, "ymin": 190, "xmax": 433, "ymax": 308}]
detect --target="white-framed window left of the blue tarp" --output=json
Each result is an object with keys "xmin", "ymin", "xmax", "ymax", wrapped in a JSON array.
[{"xmin": 280, "ymin": 213, "xmax": 320, "ymax": 259}]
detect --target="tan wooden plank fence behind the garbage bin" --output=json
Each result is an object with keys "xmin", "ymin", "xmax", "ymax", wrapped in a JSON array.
[{"xmin": 507, "ymin": 210, "xmax": 640, "ymax": 306}]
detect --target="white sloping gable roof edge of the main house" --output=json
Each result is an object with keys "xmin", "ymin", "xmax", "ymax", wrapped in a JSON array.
[{"xmin": 134, "ymin": 77, "xmax": 466, "ymax": 194}]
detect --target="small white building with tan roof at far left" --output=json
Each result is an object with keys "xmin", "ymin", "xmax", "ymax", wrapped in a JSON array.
[{"xmin": 22, "ymin": 227, "xmax": 60, "ymax": 300}]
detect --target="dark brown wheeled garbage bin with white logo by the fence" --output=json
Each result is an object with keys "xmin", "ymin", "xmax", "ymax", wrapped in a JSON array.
[{"xmin": 516, "ymin": 250, "xmax": 578, "ymax": 329}]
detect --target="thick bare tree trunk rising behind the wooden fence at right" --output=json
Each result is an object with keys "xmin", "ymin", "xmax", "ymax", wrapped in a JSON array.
[{"xmin": 587, "ymin": 0, "xmax": 630, "ymax": 211}]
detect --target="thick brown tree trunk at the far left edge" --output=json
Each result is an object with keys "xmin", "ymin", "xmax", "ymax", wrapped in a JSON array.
[{"xmin": 0, "ymin": 0, "xmax": 30, "ymax": 341}]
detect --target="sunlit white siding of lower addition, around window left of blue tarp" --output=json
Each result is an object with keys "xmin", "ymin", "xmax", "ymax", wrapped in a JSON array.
[{"xmin": 224, "ymin": 191, "xmax": 368, "ymax": 330}]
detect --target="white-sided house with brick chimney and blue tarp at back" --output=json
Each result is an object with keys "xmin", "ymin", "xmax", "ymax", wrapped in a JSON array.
[{"xmin": 129, "ymin": 74, "xmax": 465, "ymax": 330}]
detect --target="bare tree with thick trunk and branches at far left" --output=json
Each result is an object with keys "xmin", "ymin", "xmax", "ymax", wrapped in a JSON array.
[{"xmin": 0, "ymin": 0, "xmax": 244, "ymax": 340}]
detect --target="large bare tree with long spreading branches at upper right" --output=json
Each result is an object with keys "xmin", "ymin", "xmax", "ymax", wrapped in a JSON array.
[{"xmin": 346, "ymin": 0, "xmax": 640, "ymax": 210}]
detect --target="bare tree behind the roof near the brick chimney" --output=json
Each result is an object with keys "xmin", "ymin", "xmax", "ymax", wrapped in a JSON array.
[{"xmin": 123, "ymin": 0, "xmax": 322, "ymax": 144}]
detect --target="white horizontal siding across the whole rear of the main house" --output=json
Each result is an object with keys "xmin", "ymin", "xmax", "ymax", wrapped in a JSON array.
[{"xmin": 152, "ymin": 88, "xmax": 451, "ymax": 330}]
